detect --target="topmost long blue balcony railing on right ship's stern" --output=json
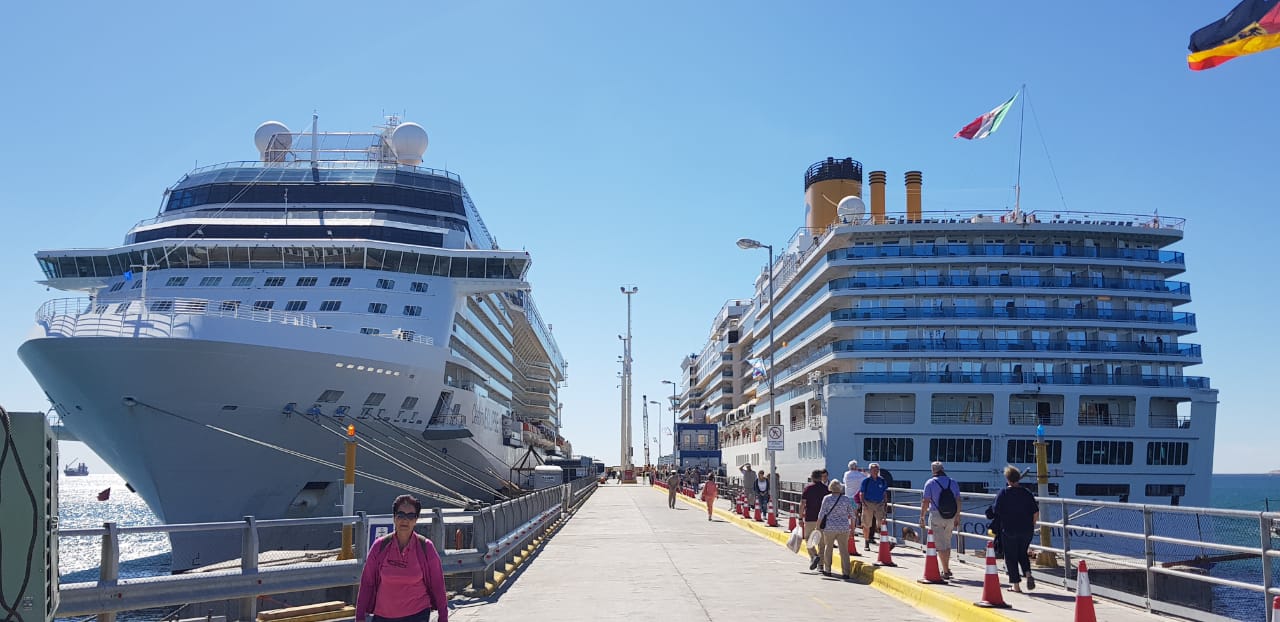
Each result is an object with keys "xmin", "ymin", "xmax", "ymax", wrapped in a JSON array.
[{"xmin": 827, "ymin": 243, "xmax": 1185, "ymax": 266}]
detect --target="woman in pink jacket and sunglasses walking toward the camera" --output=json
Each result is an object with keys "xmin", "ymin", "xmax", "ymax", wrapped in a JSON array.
[{"xmin": 356, "ymin": 494, "xmax": 449, "ymax": 622}]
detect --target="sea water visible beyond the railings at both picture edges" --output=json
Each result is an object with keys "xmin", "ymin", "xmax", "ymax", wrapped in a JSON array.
[{"xmin": 59, "ymin": 475, "xmax": 1280, "ymax": 621}]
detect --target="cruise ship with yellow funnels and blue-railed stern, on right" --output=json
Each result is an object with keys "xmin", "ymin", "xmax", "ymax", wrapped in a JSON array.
[{"xmin": 678, "ymin": 157, "xmax": 1217, "ymax": 531}]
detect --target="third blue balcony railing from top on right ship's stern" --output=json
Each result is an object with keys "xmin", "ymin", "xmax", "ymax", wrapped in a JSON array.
[{"xmin": 834, "ymin": 306, "xmax": 1196, "ymax": 330}]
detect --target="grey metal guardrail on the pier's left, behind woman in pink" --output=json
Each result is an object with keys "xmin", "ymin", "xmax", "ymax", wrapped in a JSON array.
[{"xmin": 56, "ymin": 476, "xmax": 598, "ymax": 622}]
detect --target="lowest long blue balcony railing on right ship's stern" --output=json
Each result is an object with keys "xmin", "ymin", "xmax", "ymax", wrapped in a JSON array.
[{"xmin": 826, "ymin": 371, "xmax": 1210, "ymax": 389}]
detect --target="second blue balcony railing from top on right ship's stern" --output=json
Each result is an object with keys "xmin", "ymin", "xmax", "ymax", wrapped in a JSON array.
[{"xmin": 827, "ymin": 274, "xmax": 1192, "ymax": 296}]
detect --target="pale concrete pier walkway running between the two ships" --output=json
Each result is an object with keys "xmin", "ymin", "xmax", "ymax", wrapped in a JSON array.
[{"xmin": 451, "ymin": 485, "xmax": 1169, "ymax": 622}]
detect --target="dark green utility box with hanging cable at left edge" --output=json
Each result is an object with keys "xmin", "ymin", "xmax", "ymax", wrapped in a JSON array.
[{"xmin": 0, "ymin": 412, "xmax": 58, "ymax": 622}]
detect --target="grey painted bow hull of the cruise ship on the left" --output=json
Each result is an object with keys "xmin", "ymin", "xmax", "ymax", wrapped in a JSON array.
[{"xmin": 18, "ymin": 326, "xmax": 517, "ymax": 571}]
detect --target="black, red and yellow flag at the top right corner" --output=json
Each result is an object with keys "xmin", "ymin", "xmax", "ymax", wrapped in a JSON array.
[{"xmin": 1187, "ymin": 0, "xmax": 1280, "ymax": 72}]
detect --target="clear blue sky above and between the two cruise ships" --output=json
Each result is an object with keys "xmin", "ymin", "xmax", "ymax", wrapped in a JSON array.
[{"xmin": 0, "ymin": 0, "xmax": 1280, "ymax": 472}]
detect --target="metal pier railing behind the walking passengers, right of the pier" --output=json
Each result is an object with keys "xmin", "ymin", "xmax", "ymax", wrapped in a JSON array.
[{"xmin": 717, "ymin": 478, "xmax": 1280, "ymax": 622}]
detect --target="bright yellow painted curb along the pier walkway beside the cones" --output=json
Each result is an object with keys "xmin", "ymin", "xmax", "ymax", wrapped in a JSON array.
[{"xmin": 653, "ymin": 486, "xmax": 1018, "ymax": 622}]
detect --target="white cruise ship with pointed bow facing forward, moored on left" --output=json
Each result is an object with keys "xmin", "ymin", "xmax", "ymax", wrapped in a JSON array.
[{"xmin": 18, "ymin": 118, "xmax": 572, "ymax": 571}]
